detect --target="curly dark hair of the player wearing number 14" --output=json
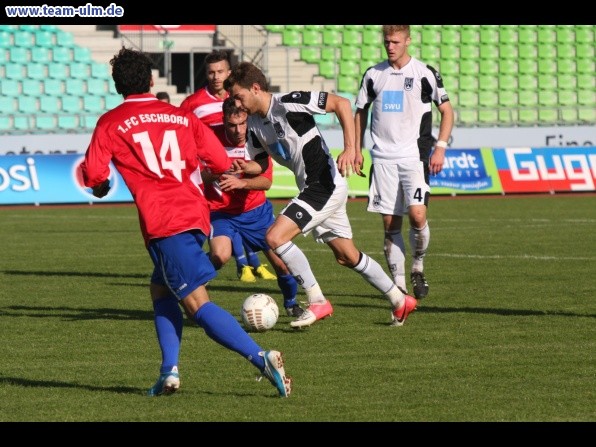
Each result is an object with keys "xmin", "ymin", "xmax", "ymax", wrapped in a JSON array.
[{"xmin": 110, "ymin": 47, "xmax": 153, "ymax": 98}]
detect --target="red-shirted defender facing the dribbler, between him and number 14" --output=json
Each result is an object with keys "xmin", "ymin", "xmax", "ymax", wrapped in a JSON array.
[{"xmin": 202, "ymin": 98, "xmax": 304, "ymax": 317}]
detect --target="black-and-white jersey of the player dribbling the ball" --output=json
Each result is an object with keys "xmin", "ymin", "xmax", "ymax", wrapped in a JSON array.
[{"xmin": 248, "ymin": 91, "xmax": 346, "ymax": 204}]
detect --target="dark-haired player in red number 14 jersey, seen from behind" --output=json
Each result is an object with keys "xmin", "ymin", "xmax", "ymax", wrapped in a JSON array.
[{"xmin": 82, "ymin": 48, "xmax": 292, "ymax": 397}]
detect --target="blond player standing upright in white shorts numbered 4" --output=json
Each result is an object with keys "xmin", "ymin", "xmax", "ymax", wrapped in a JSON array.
[{"xmin": 354, "ymin": 25, "xmax": 453, "ymax": 299}]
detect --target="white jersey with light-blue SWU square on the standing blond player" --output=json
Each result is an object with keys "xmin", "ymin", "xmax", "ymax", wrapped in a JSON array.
[{"xmin": 356, "ymin": 57, "xmax": 449, "ymax": 164}]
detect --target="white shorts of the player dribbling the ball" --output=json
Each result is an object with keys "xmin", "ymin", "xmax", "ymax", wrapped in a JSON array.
[{"xmin": 280, "ymin": 184, "xmax": 352, "ymax": 244}]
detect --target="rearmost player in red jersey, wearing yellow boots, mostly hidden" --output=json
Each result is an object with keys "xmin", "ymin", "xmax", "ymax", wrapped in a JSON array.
[{"xmin": 180, "ymin": 50, "xmax": 276, "ymax": 282}]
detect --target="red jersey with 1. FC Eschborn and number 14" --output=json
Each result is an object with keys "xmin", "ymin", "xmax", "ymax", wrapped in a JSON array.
[{"xmin": 82, "ymin": 93, "xmax": 231, "ymax": 244}]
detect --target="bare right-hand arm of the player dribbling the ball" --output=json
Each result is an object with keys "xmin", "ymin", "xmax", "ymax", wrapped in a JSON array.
[{"xmin": 325, "ymin": 93, "xmax": 360, "ymax": 177}]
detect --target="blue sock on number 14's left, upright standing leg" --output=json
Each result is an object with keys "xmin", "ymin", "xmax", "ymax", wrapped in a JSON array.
[{"xmin": 153, "ymin": 296, "xmax": 184, "ymax": 373}]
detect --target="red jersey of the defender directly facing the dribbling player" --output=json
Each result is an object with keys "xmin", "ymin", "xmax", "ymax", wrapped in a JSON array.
[{"xmin": 204, "ymin": 132, "xmax": 273, "ymax": 215}]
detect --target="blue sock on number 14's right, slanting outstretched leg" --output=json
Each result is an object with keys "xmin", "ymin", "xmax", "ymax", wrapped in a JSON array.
[{"xmin": 194, "ymin": 301, "xmax": 265, "ymax": 371}]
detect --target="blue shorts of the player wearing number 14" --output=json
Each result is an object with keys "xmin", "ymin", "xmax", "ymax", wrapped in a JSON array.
[{"xmin": 148, "ymin": 230, "xmax": 217, "ymax": 300}]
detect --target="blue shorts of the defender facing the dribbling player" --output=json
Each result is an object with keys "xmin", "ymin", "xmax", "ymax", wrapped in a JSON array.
[{"xmin": 210, "ymin": 200, "xmax": 275, "ymax": 251}]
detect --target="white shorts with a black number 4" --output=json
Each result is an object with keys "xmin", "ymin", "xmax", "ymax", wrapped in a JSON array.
[{"xmin": 366, "ymin": 160, "xmax": 430, "ymax": 216}]
